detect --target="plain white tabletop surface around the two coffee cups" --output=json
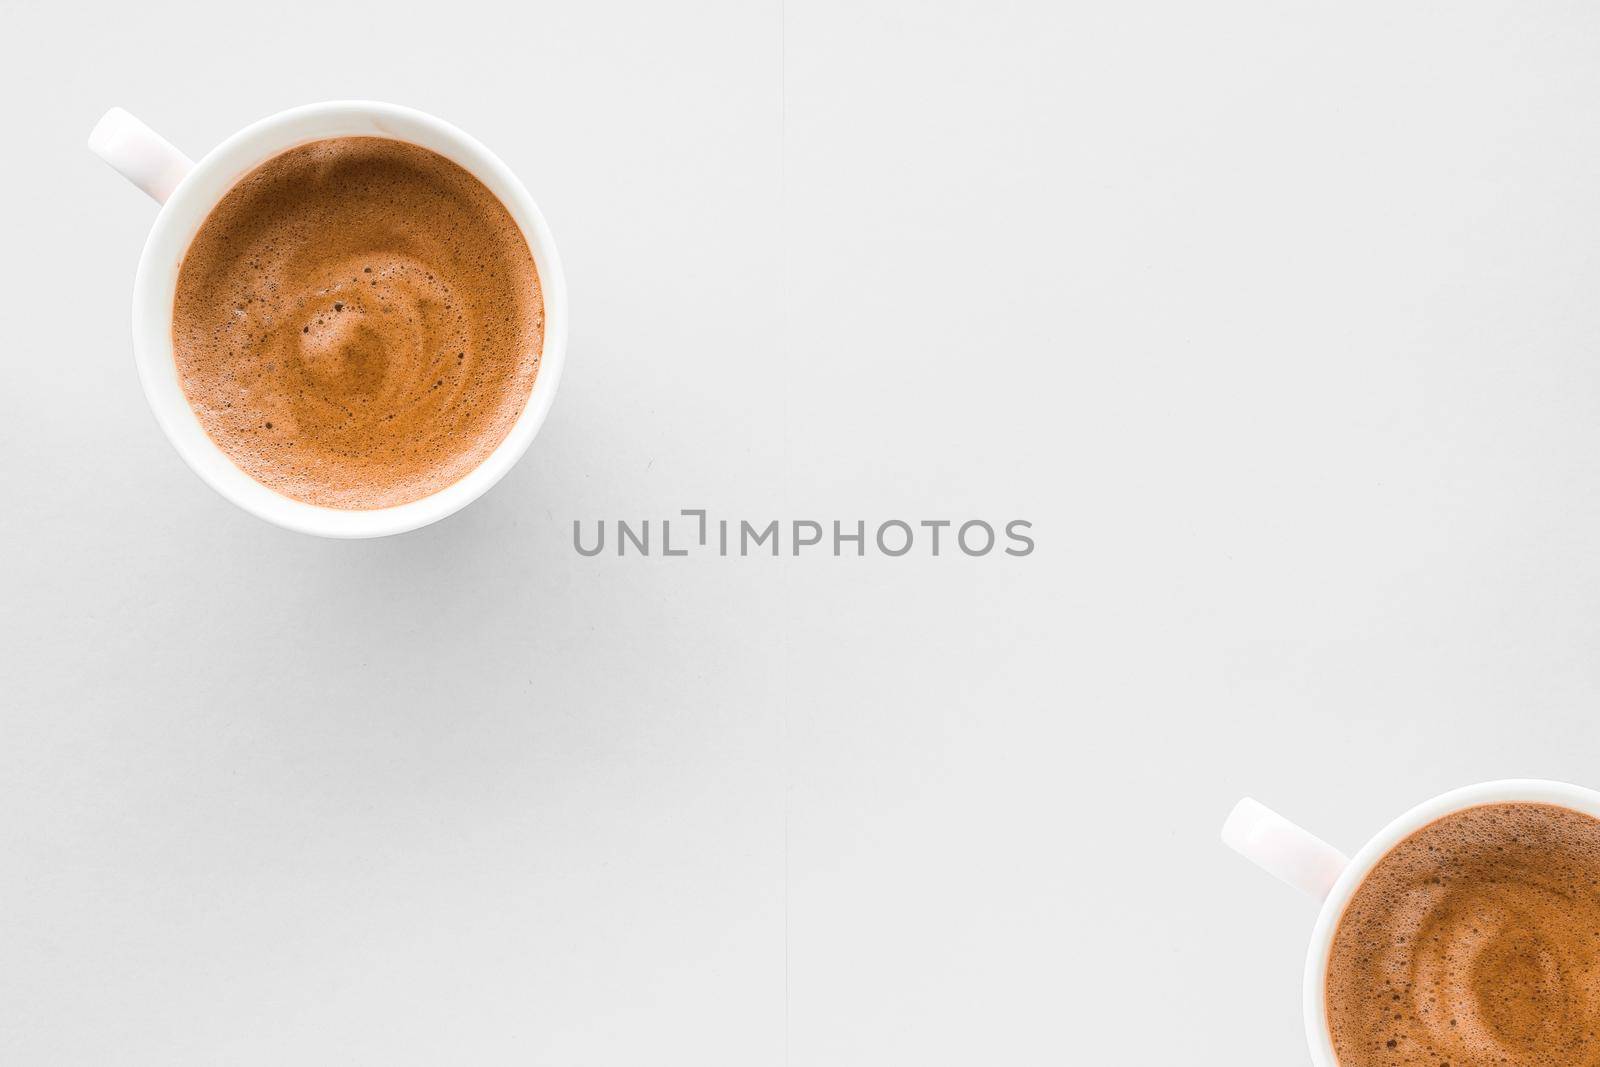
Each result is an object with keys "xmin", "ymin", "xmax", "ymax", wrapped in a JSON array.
[{"xmin": 9, "ymin": 0, "xmax": 1600, "ymax": 1067}]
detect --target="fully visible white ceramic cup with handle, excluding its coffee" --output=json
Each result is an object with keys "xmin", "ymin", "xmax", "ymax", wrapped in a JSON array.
[{"xmin": 90, "ymin": 101, "xmax": 566, "ymax": 537}]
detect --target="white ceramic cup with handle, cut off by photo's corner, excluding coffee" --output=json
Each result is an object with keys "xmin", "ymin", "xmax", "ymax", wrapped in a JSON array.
[{"xmin": 1222, "ymin": 779, "xmax": 1600, "ymax": 1067}]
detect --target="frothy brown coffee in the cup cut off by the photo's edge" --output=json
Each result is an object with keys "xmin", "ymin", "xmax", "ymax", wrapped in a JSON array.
[{"xmin": 1326, "ymin": 803, "xmax": 1600, "ymax": 1067}]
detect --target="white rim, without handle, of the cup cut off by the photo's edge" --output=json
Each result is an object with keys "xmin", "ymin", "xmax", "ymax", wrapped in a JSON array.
[{"xmin": 1304, "ymin": 777, "xmax": 1600, "ymax": 1067}]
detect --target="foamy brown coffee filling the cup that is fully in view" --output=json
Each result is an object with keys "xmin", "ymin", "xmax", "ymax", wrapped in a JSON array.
[{"xmin": 173, "ymin": 138, "xmax": 544, "ymax": 509}]
